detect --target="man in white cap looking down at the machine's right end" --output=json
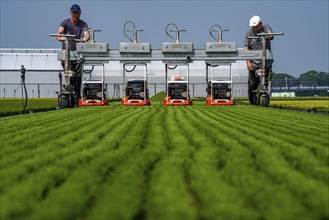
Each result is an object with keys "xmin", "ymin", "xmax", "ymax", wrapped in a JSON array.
[{"xmin": 244, "ymin": 15, "xmax": 273, "ymax": 104}]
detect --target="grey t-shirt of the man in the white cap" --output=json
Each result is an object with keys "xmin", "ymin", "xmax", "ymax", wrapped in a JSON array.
[{"xmin": 244, "ymin": 24, "xmax": 273, "ymax": 69}]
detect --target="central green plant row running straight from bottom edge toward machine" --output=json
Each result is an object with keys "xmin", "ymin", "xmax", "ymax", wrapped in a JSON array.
[{"xmin": 146, "ymin": 108, "xmax": 197, "ymax": 219}]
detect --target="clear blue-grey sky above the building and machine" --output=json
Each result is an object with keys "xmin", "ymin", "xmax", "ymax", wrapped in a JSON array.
[{"xmin": 0, "ymin": 0, "xmax": 329, "ymax": 77}]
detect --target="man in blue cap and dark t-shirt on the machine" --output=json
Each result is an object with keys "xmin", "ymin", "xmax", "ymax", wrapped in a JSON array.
[{"xmin": 56, "ymin": 4, "xmax": 89, "ymax": 104}]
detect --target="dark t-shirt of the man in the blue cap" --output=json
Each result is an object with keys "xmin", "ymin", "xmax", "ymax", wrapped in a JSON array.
[{"xmin": 60, "ymin": 18, "xmax": 88, "ymax": 51}]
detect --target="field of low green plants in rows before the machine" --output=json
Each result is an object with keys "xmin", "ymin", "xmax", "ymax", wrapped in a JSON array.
[{"xmin": 0, "ymin": 101, "xmax": 329, "ymax": 220}]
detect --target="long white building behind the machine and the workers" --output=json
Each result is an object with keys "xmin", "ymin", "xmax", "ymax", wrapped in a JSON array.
[{"xmin": 0, "ymin": 49, "xmax": 248, "ymax": 98}]
